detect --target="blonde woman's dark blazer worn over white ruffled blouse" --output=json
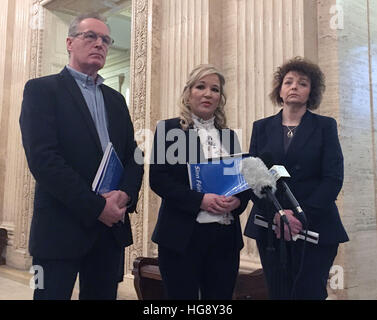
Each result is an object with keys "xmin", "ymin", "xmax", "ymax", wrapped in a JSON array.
[{"xmin": 149, "ymin": 118, "xmax": 249, "ymax": 253}]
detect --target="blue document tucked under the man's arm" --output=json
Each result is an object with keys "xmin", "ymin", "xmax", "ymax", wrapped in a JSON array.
[{"xmin": 92, "ymin": 142, "xmax": 124, "ymax": 194}]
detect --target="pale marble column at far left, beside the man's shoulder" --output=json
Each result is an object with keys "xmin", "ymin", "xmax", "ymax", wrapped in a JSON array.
[{"xmin": 1, "ymin": 0, "xmax": 33, "ymax": 269}]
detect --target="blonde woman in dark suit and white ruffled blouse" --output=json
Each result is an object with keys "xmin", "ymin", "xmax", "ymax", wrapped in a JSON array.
[{"xmin": 150, "ymin": 65, "xmax": 248, "ymax": 299}]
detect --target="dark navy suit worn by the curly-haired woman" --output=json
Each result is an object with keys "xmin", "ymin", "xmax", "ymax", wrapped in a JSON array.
[{"xmin": 245, "ymin": 111, "xmax": 349, "ymax": 299}]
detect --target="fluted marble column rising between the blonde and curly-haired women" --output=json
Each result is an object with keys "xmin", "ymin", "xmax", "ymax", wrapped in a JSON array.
[{"xmin": 221, "ymin": 0, "xmax": 316, "ymax": 271}]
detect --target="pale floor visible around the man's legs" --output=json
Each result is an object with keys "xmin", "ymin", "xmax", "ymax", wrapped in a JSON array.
[{"xmin": 0, "ymin": 265, "xmax": 137, "ymax": 300}]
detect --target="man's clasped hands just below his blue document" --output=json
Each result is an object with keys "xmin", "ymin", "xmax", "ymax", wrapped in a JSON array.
[{"xmin": 98, "ymin": 190, "xmax": 129, "ymax": 227}]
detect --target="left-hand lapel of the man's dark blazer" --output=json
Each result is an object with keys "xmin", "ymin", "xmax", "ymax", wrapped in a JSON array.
[{"xmin": 60, "ymin": 68, "xmax": 103, "ymax": 154}]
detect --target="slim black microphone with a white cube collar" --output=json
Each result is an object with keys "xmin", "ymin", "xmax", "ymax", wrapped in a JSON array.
[{"xmin": 261, "ymin": 152, "xmax": 307, "ymax": 224}]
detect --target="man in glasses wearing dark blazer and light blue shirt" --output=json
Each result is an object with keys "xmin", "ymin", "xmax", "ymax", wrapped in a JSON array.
[{"xmin": 20, "ymin": 14, "xmax": 143, "ymax": 299}]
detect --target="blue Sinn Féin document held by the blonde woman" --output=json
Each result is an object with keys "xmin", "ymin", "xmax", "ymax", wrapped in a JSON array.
[{"xmin": 187, "ymin": 154, "xmax": 250, "ymax": 196}]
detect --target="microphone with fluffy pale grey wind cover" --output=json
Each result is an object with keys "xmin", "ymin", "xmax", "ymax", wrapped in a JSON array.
[{"xmin": 241, "ymin": 157, "xmax": 289, "ymax": 225}]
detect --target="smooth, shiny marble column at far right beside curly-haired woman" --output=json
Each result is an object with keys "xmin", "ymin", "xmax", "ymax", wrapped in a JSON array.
[{"xmin": 318, "ymin": 0, "xmax": 377, "ymax": 299}]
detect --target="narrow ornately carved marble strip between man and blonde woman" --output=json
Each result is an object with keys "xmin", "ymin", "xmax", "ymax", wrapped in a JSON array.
[{"xmin": 125, "ymin": 0, "xmax": 154, "ymax": 280}]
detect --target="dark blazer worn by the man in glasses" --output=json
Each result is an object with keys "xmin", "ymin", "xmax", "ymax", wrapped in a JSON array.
[{"xmin": 20, "ymin": 68, "xmax": 143, "ymax": 259}]
